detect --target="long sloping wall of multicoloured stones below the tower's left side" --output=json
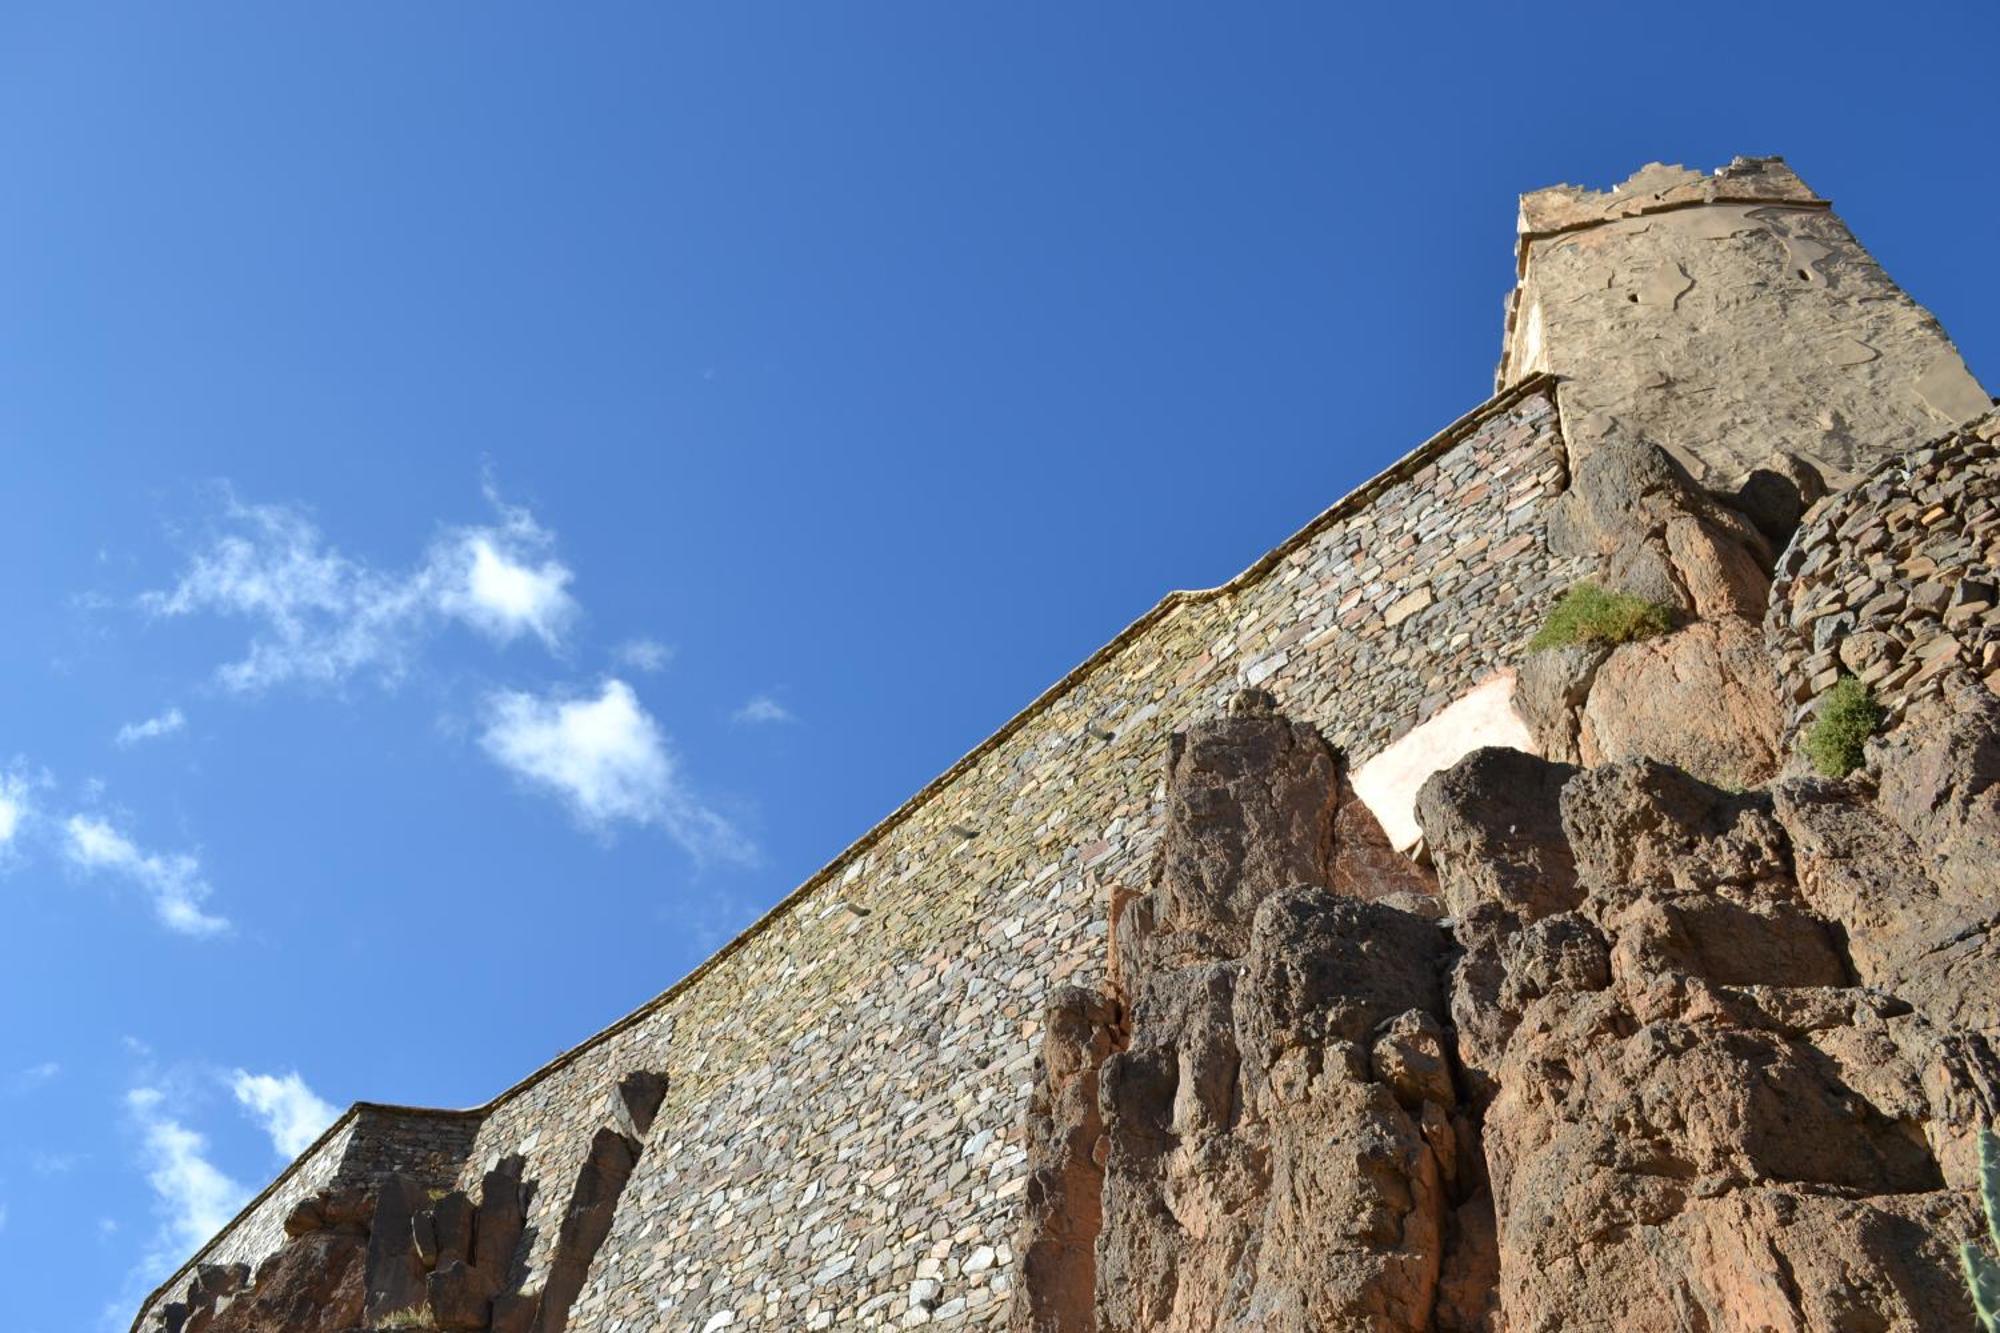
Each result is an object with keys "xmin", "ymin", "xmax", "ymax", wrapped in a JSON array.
[{"xmin": 142, "ymin": 378, "xmax": 1582, "ymax": 1333}]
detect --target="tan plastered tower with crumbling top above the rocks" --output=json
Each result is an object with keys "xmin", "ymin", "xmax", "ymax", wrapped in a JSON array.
[{"xmin": 1498, "ymin": 158, "xmax": 1990, "ymax": 486}]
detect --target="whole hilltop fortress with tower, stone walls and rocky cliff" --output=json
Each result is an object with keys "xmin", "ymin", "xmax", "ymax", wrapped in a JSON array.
[{"xmin": 134, "ymin": 158, "xmax": 2000, "ymax": 1333}]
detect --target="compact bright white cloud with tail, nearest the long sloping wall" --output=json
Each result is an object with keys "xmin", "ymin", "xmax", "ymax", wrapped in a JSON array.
[{"xmin": 480, "ymin": 681, "xmax": 752, "ymax": 861}]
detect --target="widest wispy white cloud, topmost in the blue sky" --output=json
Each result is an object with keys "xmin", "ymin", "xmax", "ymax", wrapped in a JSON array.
[{"xmin": 140, "ymin": 484, "xmax": 578, "ymax": 693}]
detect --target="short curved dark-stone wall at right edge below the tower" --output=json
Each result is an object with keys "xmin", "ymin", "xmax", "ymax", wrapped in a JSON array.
[{"xmin": 1764, "ymin": 414, "xmax": 2000, "ymax": 733}]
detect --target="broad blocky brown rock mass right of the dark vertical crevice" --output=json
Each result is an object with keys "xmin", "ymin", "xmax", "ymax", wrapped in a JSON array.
[{"xmin": 1422, "ymin": 728, "xmax": 2000, "ymax": 1333}]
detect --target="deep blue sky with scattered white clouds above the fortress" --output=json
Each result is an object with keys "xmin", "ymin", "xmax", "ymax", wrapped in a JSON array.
[{"xmin": 0, "ymin": 0, "xmax": 2000, "ymax": 1333}]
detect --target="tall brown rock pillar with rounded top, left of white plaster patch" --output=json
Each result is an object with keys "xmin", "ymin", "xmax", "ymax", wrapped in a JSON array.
[{"xmin": 1096, "ymin": 701, "xmax": 1456, "ymax": 1331}]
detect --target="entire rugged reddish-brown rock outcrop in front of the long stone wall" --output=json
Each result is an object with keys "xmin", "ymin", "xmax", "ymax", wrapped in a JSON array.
[{"xmin": 1012, "ymin": 681, "xmax": 2000, "ymax": 1333}]
